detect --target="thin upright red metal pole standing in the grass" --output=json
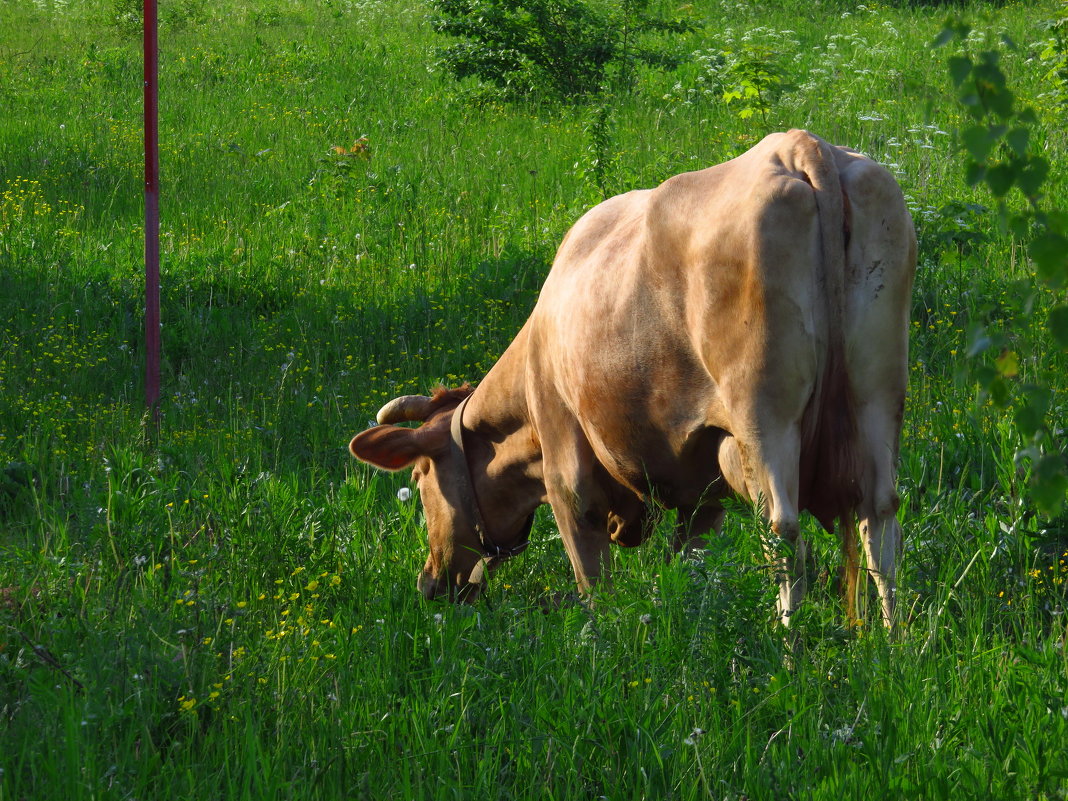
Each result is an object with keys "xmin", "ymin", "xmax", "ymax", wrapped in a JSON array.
[{"xmin": 144, "ymin": 0, "xmax": 160, "ymax": 423}]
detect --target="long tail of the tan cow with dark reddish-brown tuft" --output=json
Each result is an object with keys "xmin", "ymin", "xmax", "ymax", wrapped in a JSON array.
[{"xmin": 803, "ymin": 137, "xmax": 860, "ymax": 529}]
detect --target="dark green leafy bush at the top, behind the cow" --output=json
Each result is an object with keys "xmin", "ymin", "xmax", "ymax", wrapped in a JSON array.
[{"xmin": 431, "ymin": 0, "xmax": 688, "ymax": 97}]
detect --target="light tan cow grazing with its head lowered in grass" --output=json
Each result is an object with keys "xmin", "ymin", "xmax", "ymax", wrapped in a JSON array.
[{"xmin": 349, "ymin": 130, "xmax": 916, "ymax": 624}]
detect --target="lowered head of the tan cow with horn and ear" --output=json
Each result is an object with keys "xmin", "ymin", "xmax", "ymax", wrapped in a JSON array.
[{"xmin": 348, "ymin": 386, "xmax": 529, "ymax": 600}]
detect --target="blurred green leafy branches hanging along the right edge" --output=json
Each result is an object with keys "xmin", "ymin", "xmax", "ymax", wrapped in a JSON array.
[{"xmin": 936, "ymin": 19, "xmax": 1068, "ymax": 521}]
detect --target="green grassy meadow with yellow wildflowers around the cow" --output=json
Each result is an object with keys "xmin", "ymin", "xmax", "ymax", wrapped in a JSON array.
[{"xmin": 0, "ymin": 0, "xmax": 1068, "ymax": 801}]
